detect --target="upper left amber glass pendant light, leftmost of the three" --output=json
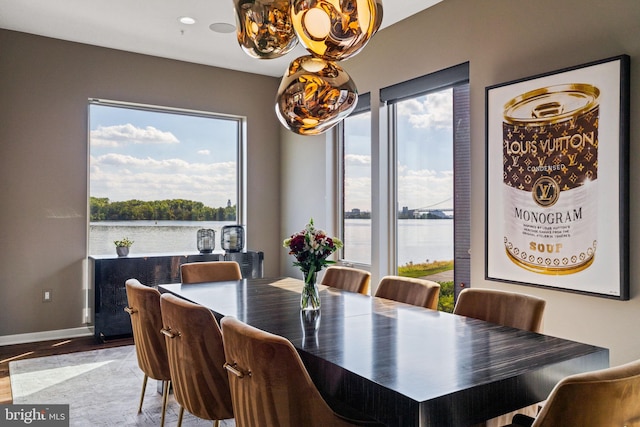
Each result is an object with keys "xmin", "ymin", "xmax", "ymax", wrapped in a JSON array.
[{"xmin": 233, "ymin": 0, "xmax": 298, "ymax": 59}]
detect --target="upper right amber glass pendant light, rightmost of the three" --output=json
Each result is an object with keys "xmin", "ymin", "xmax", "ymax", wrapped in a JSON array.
[{"xmin": 291, "ymin": 0, "xmax": 384, "ymax": 61}]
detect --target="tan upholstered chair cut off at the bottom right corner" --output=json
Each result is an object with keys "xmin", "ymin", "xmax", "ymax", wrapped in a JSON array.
[{"xmin": 502, "ymin": 360, "xmax": 640, "ymax": 427}]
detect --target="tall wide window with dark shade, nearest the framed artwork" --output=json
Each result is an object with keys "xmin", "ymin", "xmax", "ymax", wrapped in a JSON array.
[{"xmin": 380, "ymin": 64, "xmax": 470, "ymax": 311}]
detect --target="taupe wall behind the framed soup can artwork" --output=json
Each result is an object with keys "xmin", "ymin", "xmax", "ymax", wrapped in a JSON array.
[{"xmin": 283, "ymin": 0, "xmax": 640, "ymax": 364}]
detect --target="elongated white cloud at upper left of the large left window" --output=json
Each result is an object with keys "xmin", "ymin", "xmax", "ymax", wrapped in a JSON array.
[{"xmin": 90, "ymin": 123, "xmax": 180, "ymax": 147}]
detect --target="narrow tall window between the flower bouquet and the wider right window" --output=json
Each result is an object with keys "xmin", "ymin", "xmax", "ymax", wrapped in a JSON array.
[{"xmin": 340, "ymin": 94, "xmax": 371, "ymax": 264}]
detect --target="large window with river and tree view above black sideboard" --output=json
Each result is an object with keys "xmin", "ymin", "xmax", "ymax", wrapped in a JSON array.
[{"xmin": 89, "ymin": 100, "xmax": 243, "ymax": 255}]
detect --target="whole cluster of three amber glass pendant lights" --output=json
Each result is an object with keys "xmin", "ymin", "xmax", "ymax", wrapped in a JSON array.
[{"xmin": 233, "ymin": 0, "xmax": 382, "ymax": 135}]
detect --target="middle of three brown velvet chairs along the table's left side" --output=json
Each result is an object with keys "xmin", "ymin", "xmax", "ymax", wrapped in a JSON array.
[{"xmin": 160, "ymin": 294, "xmax": 233, "ymax": 426}]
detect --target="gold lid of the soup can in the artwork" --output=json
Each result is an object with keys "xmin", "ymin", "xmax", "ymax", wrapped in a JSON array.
[{"xmin": 504, "ymin": 83, "xmax": 600, "ymax": 126}]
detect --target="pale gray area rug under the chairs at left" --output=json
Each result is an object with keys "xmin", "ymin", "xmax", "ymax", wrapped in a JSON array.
[{"xmin": 9, "ymin": 346, "xmax": 235, "ymax": 427}]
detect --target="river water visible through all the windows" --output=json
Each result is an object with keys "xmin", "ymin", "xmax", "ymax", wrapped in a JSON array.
[{"xmin": 89, "ymin": 219, "xmax": 453, "ymax": 265}]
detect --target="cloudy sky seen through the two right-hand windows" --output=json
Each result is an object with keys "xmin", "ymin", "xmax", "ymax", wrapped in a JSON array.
[{"xmin": 345, "ymin": 89, "xmax": 453, "ymax": 211}]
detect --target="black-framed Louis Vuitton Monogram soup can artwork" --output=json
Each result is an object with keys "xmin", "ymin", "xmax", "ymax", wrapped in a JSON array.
[{"xmin": 485, "ymin": 55, "xmax": 630, "ymax": 300}]
